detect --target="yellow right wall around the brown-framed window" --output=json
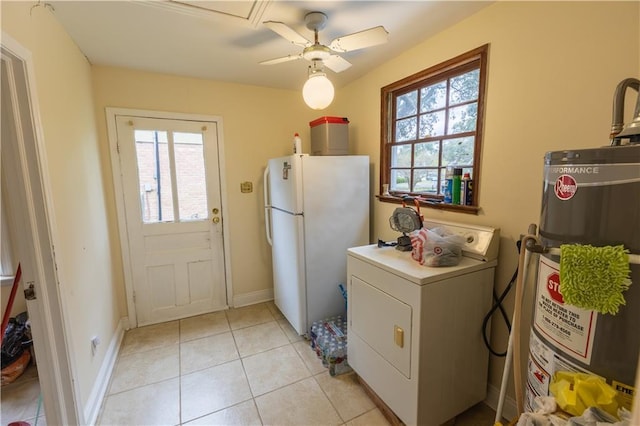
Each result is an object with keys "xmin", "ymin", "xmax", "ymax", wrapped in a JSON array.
[{"xmin": 338, "ymin": 2, "xmax": 640, "ymax": 406}]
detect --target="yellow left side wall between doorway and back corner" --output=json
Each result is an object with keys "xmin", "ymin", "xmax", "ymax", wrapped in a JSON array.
[{"xmin": 1, "ymin": 1, "xmax": 122, "ymax": 420}]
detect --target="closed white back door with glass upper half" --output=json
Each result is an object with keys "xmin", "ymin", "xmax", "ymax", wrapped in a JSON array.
[{"xmin": 116, "ymin": 116, "xmax": 226, "ymax": 325}]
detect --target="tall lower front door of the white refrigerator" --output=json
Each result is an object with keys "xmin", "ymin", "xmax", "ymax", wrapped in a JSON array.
[{"xmin": 271, "ymin": 209, "xmax": 307, "ymax": 334}]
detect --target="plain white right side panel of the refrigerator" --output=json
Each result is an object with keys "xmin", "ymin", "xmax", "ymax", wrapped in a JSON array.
[{"xmin": 302, "ymin": 156, "xmax": 369, "ymax": 327}]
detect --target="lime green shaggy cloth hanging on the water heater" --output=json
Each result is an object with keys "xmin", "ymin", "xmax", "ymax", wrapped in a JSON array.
[{"xmin": 560, "ymin": 244, "xmax": 631, "ymax": 315}]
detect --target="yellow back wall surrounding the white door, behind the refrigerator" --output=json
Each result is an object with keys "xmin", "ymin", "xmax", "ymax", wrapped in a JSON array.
[{"xmin": 93, "ymin": 66, "xmax": 336, "ymax": 314}]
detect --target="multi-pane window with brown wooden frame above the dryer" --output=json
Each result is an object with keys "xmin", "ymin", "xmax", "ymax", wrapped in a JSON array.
[{"xmin": 380, "ymin": 45, "xmax": 489, "ymax": 212}]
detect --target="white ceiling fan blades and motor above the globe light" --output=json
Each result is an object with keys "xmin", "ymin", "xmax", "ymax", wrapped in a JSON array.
[{"xmin": 260, "ymin": 12, "xmax": 389, "ymax": 72}]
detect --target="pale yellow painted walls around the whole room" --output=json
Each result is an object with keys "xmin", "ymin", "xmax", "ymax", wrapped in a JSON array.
[{"xmin": 2, "ymin": 1, "xmax": 640, "ymax": 416}]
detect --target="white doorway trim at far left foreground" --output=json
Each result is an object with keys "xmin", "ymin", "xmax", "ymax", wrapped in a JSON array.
[{"xmin": 0, "ymin": 31, "xmax": 80, "ymax": 424}]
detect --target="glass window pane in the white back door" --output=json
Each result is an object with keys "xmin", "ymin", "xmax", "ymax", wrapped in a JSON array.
[{"xmin": 135, "ymin": 130, "xmax": 208, "ymax": 223}]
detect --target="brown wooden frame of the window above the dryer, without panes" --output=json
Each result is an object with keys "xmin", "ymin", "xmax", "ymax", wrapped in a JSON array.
[{"xmin": 377, "ymin": 44, "xmax": 489, "ymax": 214}]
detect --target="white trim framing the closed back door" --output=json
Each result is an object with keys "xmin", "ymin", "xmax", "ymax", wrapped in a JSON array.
[{"xmin": 105, "ymin": 107, "xmax": 233, "ymax": 328}]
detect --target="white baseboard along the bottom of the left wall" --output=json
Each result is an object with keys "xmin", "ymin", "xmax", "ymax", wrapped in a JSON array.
[{"xmin": 84, "ymin": 317, "xmax": 129, "ymax": 425}]
